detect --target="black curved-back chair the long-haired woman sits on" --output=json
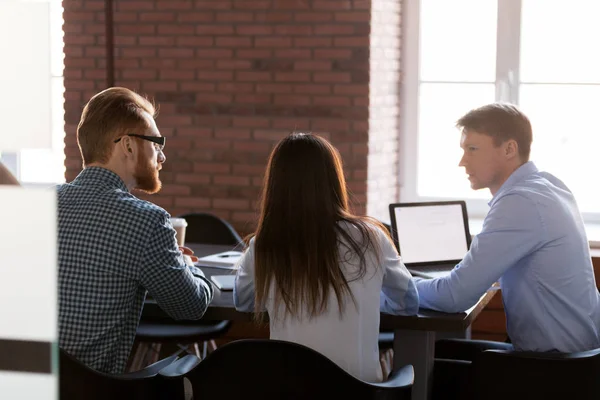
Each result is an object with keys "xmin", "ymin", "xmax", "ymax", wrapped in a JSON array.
[{"xmin": 160, "ymin": 339, "xmax": 414, "ymax": 400}]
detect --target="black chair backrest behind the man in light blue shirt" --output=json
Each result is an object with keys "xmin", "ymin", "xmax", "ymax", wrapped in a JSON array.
[{"xmin": 473, "ymin": 349, "xmax": 600, "ymax": 400}]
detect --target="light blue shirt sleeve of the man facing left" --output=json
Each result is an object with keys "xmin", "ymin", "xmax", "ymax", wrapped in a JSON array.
[{"xmin": 415, "ymin": 193, "xmax": 546, "ymax": 313}]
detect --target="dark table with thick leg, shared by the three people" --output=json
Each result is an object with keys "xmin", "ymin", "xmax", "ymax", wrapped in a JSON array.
[{"xmin": 149, "ymin": 243, "xmax": 496, "ymax": 400}]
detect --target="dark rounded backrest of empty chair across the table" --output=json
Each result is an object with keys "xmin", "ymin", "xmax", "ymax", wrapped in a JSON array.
[{"xmin": 179, "ymin": 213, "xmax": 242, "ymax": 247}]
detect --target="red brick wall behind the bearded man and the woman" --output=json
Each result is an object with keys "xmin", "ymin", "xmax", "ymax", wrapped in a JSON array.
[{"xmin": 63, "ymin": 0, "xmax": 399, "ymax": 233}]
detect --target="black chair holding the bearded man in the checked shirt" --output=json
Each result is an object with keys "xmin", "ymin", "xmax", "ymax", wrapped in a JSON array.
[{"xmin": 59, "ymin": 349, "xmax": 183, "ymax": 400}]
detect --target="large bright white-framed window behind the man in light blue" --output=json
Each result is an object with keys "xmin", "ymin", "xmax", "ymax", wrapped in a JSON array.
[{"xmin": 401, "ymin": 0, "xmax": 600, "ymax": 221}]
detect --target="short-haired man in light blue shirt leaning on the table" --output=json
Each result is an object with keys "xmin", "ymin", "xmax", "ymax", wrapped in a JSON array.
[{"xmin": 416, "ymin": 104, "xmax": 600, "ymax": 352}]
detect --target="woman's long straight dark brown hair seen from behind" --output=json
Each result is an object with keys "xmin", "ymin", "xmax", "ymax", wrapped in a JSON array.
[{"xmin": 254, "ymin": 133, "xmax": 390, "ymax": 319}]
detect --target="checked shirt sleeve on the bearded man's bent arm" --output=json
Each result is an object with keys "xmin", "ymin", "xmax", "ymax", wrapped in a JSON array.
[{"xmin": 140, "ymin": 216, "xmax": 213, "ymax": 319}]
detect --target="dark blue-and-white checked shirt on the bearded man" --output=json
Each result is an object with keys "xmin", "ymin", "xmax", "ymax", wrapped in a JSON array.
[{"xmin": 58, "ymin": 167, "xmax": 213, "ymax": 374}]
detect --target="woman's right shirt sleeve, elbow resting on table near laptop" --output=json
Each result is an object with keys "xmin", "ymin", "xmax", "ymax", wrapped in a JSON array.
[{"xmin": 379, "ymin": 228, "xmax": 419, "ymax": 315}]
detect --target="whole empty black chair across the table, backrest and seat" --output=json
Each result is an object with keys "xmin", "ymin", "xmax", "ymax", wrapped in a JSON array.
[{"xmin": 131, "ymin": 213, "xmax": 242, "ymax": 370}]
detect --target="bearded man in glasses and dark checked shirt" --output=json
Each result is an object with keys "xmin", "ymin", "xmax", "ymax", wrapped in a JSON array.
[{"xmin": 58, "ymin": 88, "xmax": 213, "ymax": 374}]
